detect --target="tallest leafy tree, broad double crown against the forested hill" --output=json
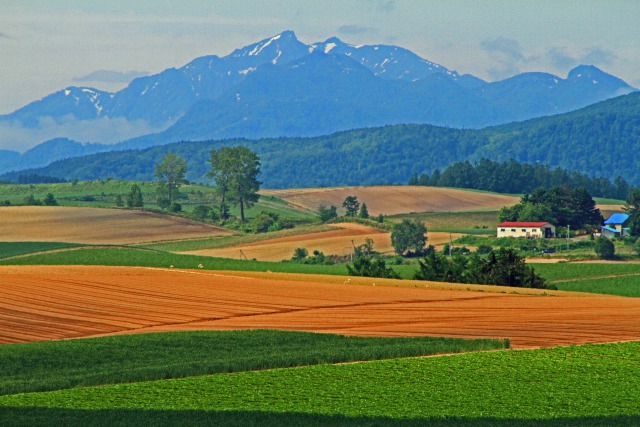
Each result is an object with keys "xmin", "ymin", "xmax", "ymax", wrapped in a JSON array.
[{"xmin": 208, "ymin": 146, "xmax": 261, "ymax": 222}]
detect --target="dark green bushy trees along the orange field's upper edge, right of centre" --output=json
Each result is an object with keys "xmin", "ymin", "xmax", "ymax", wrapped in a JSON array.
[{"xmin": 414, "ymin": 249, "xmax": 547, "ymax": 288}]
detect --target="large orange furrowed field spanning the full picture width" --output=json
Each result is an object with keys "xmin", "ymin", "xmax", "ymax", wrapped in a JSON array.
[{"xmin": 0, "ymin": 266, "xmax": 640, "ymax": 348}]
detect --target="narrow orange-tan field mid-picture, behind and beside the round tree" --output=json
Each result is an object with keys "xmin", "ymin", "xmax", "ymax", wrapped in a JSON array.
[{"xmin": 185, "ymin": 223, "xmax": 461, "ymax": 261}]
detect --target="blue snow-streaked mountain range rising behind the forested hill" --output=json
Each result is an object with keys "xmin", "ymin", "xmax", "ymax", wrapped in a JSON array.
[{"xmin": 0, "ymin": 31, "xmax": 635, "ymax": 175}]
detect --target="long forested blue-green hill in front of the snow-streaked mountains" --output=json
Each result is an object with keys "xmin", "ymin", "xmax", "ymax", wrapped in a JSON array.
[{"xmin": 5, "ymin": 93, "xmax": 640, "ymax": 188}]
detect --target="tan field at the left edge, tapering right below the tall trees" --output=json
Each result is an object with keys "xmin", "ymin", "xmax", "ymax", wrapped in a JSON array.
[{"xmin": 0, "ymin": 206, "xmax": 232, "ymax": 244}]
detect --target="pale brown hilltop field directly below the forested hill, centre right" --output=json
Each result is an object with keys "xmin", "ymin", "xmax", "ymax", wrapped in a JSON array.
[{"xmin": 260, "ymin": 186, "xmax": 520, "ymax": 215}]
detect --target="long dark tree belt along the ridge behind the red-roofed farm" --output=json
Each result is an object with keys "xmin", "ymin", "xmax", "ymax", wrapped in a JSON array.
[{"xmin": 409, "ymin": 158, "xmax": 633, "ymax": 200}]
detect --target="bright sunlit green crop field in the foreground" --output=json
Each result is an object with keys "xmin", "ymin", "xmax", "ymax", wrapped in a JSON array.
[{"xmin": 0, "ymin": 342, "xmax": 640, "ymax": 425}]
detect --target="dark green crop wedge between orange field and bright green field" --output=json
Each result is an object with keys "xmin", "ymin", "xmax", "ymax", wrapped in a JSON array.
[{"xmin": 0, "ymin": 330, "xmax": 509, "ymax": 394}]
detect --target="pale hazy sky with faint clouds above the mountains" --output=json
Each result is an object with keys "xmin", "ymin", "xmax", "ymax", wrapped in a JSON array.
[{"xmin": 0, "ymin": 0, "xmax": 640, "ymax": 114}]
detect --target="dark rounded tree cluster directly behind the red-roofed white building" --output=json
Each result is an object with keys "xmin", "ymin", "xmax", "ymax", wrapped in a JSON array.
[{"xmin": 498, "ymin": 185, "xmax": 604, "ymax": 230}]
